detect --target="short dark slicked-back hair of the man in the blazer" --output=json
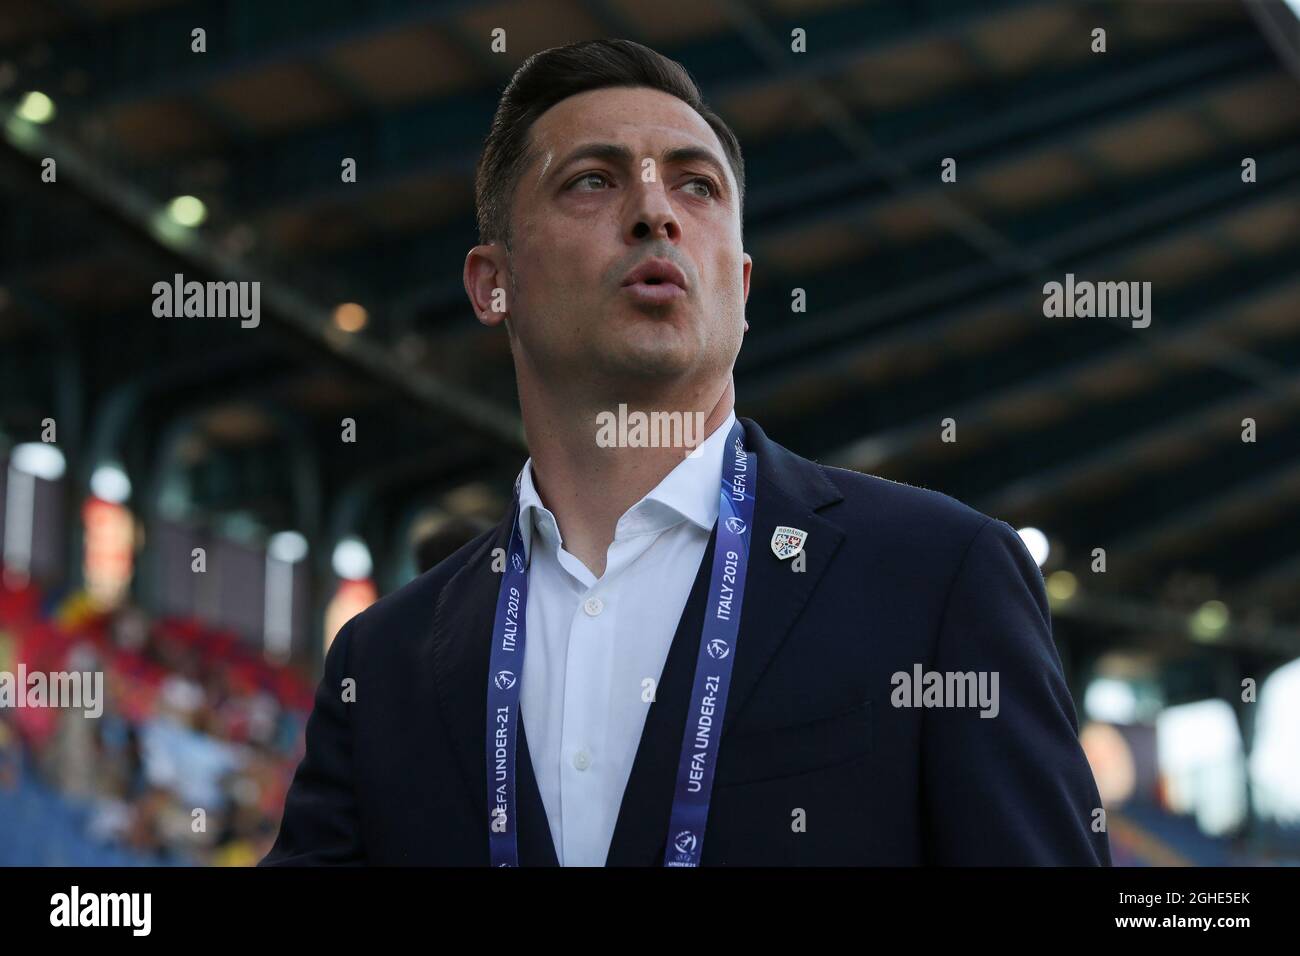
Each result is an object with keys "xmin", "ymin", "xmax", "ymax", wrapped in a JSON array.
[{"xmin": 475, "ymin": 40, "xmax": 745, "ymax": 246}]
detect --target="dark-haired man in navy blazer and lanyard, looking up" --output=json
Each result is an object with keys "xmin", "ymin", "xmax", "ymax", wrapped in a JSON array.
[{"xmin": 264, "ymin": 40, "xmax": 1110, "ymax": 866}]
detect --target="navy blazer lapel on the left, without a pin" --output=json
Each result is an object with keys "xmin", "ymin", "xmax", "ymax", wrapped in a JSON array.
[{"xmin": 432, "ymin": 510, "xmax": 558, "ymax": 866}]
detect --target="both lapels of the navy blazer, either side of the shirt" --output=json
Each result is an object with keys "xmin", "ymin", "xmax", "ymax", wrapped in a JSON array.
[{"xmin": 430, "ymin": 418, "xmax": 844, "ymax": 866}]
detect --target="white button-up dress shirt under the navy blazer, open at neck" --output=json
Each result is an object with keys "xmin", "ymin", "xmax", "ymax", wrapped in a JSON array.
[{"xmin": 519, "ymin": 411, "xmax": 736, "ymax": 866}]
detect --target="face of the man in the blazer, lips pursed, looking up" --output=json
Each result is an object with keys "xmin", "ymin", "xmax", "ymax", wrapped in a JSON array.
[{"xmin": 488, "ymin": 87, "xmax": 751, "ymax": 398}]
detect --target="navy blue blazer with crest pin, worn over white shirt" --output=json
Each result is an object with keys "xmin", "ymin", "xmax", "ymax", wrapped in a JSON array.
[{"xmin": 261, "ymin": 419, "xmax": 1110, "ymax": 866}]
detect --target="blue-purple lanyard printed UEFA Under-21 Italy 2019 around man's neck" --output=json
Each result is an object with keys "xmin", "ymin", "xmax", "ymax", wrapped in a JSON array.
[{"xmin": 486, "ymin": 420, "xmax": 758, "ymax": 866}]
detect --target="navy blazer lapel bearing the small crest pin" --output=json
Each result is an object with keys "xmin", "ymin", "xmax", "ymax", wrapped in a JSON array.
[{"xmin": 606, "ymin": 418, "xmax": 844, "ymax": 866}]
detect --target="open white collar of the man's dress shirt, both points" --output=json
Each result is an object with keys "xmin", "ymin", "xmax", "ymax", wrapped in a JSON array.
[{"xmin": 519, "ymin": 408, "xmax": 736, "ymax": 561}]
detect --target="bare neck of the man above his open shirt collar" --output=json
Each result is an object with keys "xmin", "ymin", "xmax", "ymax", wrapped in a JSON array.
[{"xmin": 520, "ymin": 373, "xmax": 736, "ymax": 578}]
